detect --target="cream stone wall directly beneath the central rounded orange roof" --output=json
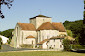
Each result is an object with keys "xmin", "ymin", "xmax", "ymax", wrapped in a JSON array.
[{"xmin": 38, "ymin": 30, "xmax": 59, "ymax": 43}]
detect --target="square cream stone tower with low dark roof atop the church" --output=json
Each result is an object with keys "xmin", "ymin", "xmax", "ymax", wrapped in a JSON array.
[{"xmin": 30, "ymin": 15, "xmax": 52, "ymax": 29}]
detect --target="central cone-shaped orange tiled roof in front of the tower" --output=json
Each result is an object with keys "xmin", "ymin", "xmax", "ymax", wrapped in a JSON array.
[{"xmin": 37, "ymin": 22, "xmax": 56, "ymax": 30}]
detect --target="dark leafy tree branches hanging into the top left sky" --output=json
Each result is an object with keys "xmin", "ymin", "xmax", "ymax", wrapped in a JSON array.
[{"xmin": 0, "ymin": 0, "xmax": 14, "ymax": 19}]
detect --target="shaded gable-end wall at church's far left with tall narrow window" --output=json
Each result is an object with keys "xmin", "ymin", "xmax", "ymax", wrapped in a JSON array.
[{"xmin": 11, "ymin": 24, "xmax": 21, "ymax": 48}]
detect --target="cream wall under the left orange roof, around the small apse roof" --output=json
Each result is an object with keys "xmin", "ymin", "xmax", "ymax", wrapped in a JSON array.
[{"xmin": 21, "ymin": 30, "xmax": 37, "ymax": 44}]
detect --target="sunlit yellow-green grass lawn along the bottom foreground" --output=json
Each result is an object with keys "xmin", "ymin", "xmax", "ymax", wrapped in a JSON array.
[{"xmin": 0, "ymin": 51, "xmax": 85, "ymax": 56}]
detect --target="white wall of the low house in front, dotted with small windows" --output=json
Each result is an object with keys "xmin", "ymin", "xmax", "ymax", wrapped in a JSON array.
[{"xmin": 42, "ymin": 39, "xmax": 64, "ymax": 50}]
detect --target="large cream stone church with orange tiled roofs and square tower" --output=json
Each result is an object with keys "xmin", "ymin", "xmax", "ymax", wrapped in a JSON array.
[{"xmin": 11, "ymin": 15, "xmax": 67, "ymax": 50}]
